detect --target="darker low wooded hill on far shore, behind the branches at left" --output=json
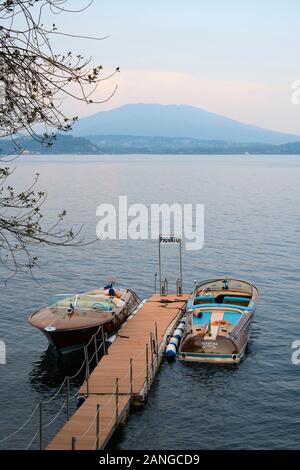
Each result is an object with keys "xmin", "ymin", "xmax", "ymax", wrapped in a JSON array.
[{"xmin": 0, "ymin": 134, "xmax": 101, "ymax": 155}]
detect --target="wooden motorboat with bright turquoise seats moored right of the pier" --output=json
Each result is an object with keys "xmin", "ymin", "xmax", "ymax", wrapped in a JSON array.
[{"xmin": 178, "ymin": 279, "xmax": 259, "ymax": 363}]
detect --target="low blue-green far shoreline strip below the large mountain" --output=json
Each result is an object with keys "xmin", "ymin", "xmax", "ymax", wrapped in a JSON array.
[{"xmin": 0, "ymin": 134, "xmax": 300, "ymax": 156}]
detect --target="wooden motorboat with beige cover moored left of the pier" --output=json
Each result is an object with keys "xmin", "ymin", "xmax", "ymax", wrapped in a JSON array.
[{"xmin": 28, "ymin": 286, "xmax": 140, "ymax": 353}]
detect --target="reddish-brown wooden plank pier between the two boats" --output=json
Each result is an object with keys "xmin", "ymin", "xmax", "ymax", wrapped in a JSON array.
[{"xmin": 48, "ymin": 295, "xmax": 188, "ymax": 450}]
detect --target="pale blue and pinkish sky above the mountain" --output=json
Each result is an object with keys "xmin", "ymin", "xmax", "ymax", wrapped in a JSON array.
[{"xmin": 45, "ymin": 0, "xmax": 300, "ymax": 134}]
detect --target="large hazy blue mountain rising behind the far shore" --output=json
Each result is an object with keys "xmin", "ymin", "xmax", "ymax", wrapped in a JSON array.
[{"xmin": 73, "ymin": 104, "xmax": 300, "ymax": 144}]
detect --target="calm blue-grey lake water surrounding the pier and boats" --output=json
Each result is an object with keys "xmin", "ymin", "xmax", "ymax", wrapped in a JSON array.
[{"xmin": 0, "ymin": 156, "xmax": 300, "ymax": 449}]
